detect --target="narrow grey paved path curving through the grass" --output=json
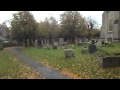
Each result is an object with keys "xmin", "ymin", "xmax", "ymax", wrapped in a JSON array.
[{"xmin": 11, "ymin": 48, "xmax": 72, "ymax": 79}]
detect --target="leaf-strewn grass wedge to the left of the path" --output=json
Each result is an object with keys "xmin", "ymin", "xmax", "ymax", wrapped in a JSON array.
[{"xmin": 0, "ymin": 49, "xmax": 42, "ymax": 79}]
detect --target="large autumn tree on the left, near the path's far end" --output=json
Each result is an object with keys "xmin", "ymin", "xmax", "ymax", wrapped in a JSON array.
[{"xmin": 11, "ymin": 11, "xmax": 37, "ymax": 46}]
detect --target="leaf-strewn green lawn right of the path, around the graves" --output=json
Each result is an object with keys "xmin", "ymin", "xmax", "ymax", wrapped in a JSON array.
[{"xmin": 22, "ymin": 44, "xmax": 120, "ymax": 79}]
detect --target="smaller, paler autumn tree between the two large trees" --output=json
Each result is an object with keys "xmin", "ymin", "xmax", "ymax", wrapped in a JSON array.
[{"xmin": 38, "ymin": 16, "xmax": 59, "ymax": 44}]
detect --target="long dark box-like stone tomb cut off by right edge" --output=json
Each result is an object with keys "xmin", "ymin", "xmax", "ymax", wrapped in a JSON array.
[{"xmin": 99, "ymin": 56, "xmax": 120, "ymax": 68}]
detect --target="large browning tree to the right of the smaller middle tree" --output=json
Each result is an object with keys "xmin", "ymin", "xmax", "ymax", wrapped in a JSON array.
[{"xmin": 60, "ymin": 11, "xmax": 86, "ymax": 42}]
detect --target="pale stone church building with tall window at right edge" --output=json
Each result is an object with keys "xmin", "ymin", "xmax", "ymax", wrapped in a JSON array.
[{"xmin": 101, "ymin": 11, "xmax": 120, "ymax": 41}]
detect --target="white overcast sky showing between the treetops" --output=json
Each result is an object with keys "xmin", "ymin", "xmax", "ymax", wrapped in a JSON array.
[{"xmin": 0, "ymin": 11, "xmax": 103, "ymax": 26}]
